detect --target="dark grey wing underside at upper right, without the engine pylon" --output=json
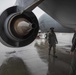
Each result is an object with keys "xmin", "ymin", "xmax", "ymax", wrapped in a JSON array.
[{"xmin": 39, "ymin": 0, "xmax": 76, "ymax": 29}]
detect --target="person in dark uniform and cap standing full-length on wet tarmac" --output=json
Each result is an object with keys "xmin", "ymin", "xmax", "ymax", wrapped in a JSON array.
[{"xmin": 48, "ymin": 27, "xmax": 58, "ymax": 57}]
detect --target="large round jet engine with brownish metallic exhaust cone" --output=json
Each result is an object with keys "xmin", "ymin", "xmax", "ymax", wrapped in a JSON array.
[{"xmin": 0, "ymin": 6, "xmax": 39, "ymax": 47}]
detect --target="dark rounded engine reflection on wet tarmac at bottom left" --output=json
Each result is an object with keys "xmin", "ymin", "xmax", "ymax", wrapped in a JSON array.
[{"xmin": 0, "ymin": 57, "xmax": 31, "ymax": 75}]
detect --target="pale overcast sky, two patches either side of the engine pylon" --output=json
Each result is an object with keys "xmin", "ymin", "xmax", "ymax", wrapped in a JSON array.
[{"xmin": 0, "ymin": 0, "xmax": 44, "ymax": 19}]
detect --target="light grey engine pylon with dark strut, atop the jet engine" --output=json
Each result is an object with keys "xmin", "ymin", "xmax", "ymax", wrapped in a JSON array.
[{"xmin": 16, "ymin": 0, "xmax": 44, "ymax": 11}]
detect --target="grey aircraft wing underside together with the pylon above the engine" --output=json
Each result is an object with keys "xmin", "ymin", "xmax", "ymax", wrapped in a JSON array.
[{"xmin": 16, "ymin": 0, "xmax": 76, "ymax": 28}]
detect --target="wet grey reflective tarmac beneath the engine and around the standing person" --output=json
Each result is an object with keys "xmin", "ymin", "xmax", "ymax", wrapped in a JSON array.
[{"xmin": 0, "ymin": 33, "xmax": 73, "ymax": 75}]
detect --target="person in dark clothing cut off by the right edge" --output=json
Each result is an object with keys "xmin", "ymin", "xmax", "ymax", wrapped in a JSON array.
[{"xmin": 69, "ymin": 32, "xmax": 76, "ymax": 75}]
